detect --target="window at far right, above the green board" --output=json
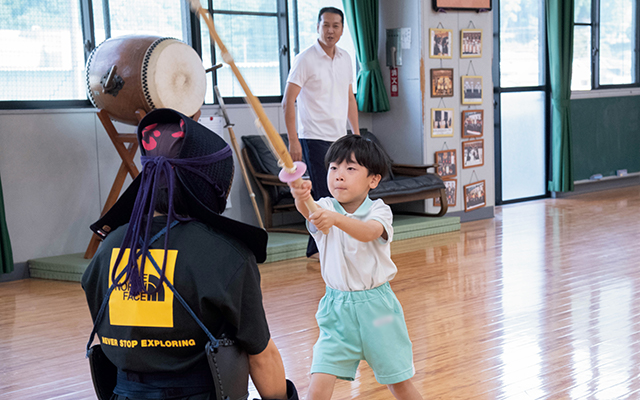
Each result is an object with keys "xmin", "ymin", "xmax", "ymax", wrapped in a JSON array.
[{"xmin": 571, "ymin": 0, "xmax": 638, "ymax": 90}]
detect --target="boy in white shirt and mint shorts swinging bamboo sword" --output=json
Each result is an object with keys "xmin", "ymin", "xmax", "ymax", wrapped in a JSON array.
[{"xmin": 291, "ymin": 135, "xmax": 422, "ymax": 400}]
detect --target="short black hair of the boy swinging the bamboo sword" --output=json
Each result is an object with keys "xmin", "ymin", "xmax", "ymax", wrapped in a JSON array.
[{"xmin": 324, "ymin": 135, "xmax": 391, "ymax": 178}]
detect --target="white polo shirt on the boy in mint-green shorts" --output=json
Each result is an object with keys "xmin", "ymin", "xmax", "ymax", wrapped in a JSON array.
[{"xmin": 308, "ymin": 197, "xmax": 398, "ymax": 291}]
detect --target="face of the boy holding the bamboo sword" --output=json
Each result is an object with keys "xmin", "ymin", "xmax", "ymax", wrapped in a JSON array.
[{"xmin": 327, "ymin": 158, "xmax": 381, "ymax": 214}]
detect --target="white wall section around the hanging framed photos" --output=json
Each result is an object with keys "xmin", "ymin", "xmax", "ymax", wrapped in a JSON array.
[{"xmin": 372, "ymin": 0, "xmax": 495, "ymax": 216}]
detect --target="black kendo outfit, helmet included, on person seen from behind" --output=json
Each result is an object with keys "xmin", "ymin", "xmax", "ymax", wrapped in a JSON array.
[{"xmin": 82, "ymin": 109, "xmax": 297, "ymax": 400}]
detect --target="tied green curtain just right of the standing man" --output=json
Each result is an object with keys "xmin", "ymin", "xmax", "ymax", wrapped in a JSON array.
[{"xmin": 342, "ymin": 0, "xmax": 389, "ymax": 112}]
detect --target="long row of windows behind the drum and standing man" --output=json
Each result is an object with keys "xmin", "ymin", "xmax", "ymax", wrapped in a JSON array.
[{"xmin": 0, "ymin": 0, "xmax": 356, "ymax": 108}]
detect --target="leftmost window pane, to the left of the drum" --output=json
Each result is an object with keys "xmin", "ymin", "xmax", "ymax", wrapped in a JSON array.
[{"xmin": 0, "ymin": 0, "xmax": 87, "ymax": 101}]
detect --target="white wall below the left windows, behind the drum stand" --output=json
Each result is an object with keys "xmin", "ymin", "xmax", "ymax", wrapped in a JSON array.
[{"xmin": 0, "ymin": 104, "xmax": 372, "ymax": 263}]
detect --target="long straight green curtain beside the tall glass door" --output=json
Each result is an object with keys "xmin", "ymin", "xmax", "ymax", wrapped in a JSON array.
[{"xmin": 546, "ymin": 0, "xmax": 574, "ymax": 192}]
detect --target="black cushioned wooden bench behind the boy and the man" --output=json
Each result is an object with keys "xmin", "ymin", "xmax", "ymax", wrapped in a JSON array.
[{"xmin": 242, "ymin": 129, "xmax": 447, "ymax": 233}]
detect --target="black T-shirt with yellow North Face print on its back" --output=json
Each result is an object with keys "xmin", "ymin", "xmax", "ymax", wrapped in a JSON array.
[{"xmin": 82, "ymin": 216, "xmax": 270, "ymax": 396}]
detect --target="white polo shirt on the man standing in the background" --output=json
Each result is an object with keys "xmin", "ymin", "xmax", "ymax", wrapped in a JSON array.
[{"xmin": 287, "ymin": 40, "xmax": 353, "ymax": 142}]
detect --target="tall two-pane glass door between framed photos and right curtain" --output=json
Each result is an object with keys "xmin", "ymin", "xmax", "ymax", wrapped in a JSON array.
[{"xmin": 493, "ymin": 0, "xmax": 548, "ymax": 204}]
